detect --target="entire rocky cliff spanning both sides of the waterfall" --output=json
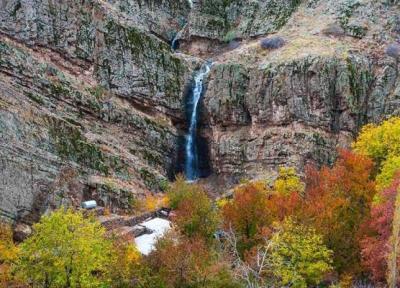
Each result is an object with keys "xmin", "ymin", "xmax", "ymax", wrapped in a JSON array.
[{"xmin": 0, "ymin": 0, "xmax": 400, "ymax": 217}]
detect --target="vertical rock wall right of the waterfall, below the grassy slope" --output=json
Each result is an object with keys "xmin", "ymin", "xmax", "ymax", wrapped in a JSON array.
[{"xmin": 205, "ymin": 53, "xmax": 399, "ymax": 181}]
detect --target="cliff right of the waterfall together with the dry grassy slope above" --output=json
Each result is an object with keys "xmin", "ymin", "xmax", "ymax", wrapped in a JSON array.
[{"xmin": 203, "ymin": 1, "xmax": 400, "ymax": 181}]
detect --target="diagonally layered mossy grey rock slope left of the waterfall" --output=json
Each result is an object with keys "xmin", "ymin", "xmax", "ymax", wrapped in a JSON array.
[{"xmin": 0, "ymin": 1, "xmax": 191, "ymax": 217}]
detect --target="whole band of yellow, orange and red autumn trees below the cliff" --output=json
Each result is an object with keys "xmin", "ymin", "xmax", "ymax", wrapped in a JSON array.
[{"xmin": 0, "ymin": 118, "xmax": 400, "ymax": 288}]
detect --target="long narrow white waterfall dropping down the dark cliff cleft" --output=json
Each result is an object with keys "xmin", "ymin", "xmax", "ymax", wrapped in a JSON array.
[{"xmin": 185, "ymin": 62, "xmax": 212, "ymax": 181}]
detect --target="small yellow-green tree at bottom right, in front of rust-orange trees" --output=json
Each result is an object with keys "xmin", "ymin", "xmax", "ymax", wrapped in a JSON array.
[{"xmin": 271, "ymin": 218, "xmax": 332, "ymax": 287}]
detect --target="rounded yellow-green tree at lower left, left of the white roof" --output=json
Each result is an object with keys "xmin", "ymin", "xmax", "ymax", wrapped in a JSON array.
[{"xmin": 17, "ymin": 208, "xmax": 113, "ymax": 288}]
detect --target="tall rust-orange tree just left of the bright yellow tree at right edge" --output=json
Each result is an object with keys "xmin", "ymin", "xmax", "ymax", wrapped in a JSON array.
[{"xmin": 299, "ymin": 150, "xmax": 375, "ymax": 273}]
